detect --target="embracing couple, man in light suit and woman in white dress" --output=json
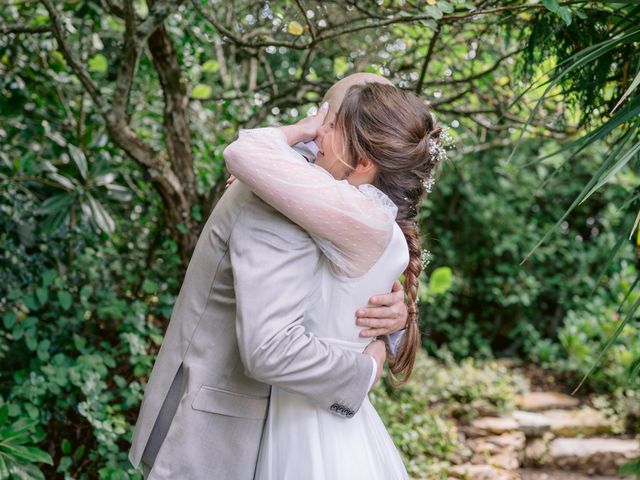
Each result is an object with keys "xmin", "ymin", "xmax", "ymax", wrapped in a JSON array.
[{"xmin": 130, "ymin": 73, "xmax": 440, "ymax": 480}]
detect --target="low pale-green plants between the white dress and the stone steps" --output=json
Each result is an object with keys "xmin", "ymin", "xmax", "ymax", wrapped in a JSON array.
[{"xmin": 371, "ymin": 352, "xmax": 526, "ymax": 478}]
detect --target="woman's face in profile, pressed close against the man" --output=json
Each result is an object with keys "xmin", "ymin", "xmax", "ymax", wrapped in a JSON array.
[{"xmin": 314, "ymin": 102, "xmax": 353, "ymax": 180}]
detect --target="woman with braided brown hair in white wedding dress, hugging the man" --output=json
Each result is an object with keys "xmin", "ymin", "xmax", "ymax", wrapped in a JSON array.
[{"xmin": 224, "ymin": 75, "xmax": 442, "ymax": 480}]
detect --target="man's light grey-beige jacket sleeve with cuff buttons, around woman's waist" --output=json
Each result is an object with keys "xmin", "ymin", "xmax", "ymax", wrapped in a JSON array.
[{"xmin": 229, "ymin": 204, "xmax": 372, "ymax": 418}]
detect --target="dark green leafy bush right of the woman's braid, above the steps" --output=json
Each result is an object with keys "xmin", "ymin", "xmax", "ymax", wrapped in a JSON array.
[{"xmin": 421, "ymin": 138, "xmax": 636, "ymax": 358}]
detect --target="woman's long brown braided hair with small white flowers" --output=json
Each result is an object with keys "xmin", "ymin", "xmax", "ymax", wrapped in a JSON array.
[{"xmin": 335, "ymin": 82, "xmax": 442, "ymax": 384}]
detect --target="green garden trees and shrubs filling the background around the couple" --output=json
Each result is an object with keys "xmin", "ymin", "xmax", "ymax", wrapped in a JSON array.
[{"xmin": 0, "ymin": 0, "xmax": 640, "ymax": 479}]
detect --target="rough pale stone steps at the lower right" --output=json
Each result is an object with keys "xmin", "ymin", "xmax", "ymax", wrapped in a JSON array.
[{"xmin": 450, "ymin": 392, "xmax": 640, "ymax": 480}]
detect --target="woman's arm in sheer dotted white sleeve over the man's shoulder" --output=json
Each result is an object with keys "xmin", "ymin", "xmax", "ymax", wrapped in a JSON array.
[{"xmin": 224, "ymin": 127, "xmax": 395, "ymax": 276}]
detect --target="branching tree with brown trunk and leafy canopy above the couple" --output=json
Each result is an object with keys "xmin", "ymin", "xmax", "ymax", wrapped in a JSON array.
[{"xmin": 0, "ymin": 0, "xmax": 580, "ymax": 262}]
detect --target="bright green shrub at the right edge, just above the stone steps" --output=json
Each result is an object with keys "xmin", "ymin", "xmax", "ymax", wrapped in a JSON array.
[{"xmin": 527, "ymin": 264, "xmax": 640, "ymax": 433}]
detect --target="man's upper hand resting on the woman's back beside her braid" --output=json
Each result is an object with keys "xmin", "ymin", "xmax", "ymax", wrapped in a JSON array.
[{"xmin": 356, "ymin": 280, "xmax": 407, "ymax": 337}]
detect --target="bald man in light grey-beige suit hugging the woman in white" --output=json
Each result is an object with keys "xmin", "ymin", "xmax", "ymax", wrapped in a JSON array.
[{"xmin": 129, "ymin": 74, "xmax": 406, "ymax": 480}]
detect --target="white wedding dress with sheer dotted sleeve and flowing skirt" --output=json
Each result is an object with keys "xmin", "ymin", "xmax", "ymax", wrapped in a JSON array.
[{"xmin": 228, "ymin": 128, "xmax": 409, "ymax": 480}]
